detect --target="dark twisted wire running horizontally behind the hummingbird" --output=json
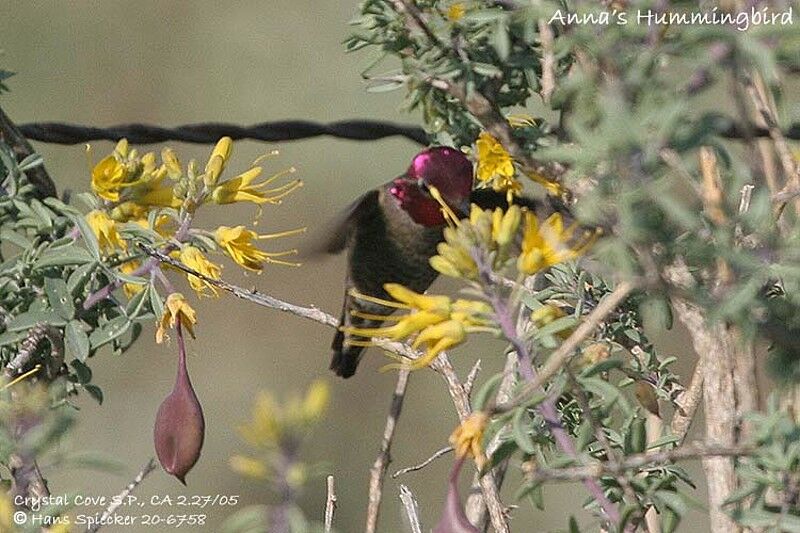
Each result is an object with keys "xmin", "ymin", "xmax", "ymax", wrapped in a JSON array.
[{"xmin": 19, "ymin": 117, "xmax": 800, "ymax": 145}]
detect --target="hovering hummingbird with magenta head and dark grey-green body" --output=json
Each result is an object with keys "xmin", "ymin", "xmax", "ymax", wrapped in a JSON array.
[{"xmin": 323, "ymin": 146, "xmax": 538, "ymax": 378}]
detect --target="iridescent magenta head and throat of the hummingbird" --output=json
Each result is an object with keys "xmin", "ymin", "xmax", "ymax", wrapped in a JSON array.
[{"xmin": 390, "ymin": 146, "xmax": 472, "ymax": 226}]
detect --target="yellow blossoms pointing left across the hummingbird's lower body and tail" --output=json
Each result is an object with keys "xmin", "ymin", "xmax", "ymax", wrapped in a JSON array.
[{"xmin": 345, "ymin": 283, "xmax": 495, "ymax": 370}]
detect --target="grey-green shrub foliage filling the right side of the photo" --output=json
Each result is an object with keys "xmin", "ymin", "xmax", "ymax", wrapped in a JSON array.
[{"xmin": 346, "ymin": 0, "xmax": 800, "ymax": 531}]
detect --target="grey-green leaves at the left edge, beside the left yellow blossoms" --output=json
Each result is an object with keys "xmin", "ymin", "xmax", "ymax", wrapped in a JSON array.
[{"xmin": 0, "ymin": 141, "xmax": 153, "ymax": 401}]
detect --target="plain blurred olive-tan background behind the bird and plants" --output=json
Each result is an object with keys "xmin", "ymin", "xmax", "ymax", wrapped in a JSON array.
[{"xmin": 0, "ymin": 0, "xmax": 705, "ymax": 532}]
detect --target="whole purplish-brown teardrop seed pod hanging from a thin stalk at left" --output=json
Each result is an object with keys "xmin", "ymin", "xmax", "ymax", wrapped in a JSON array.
[{"xmin": 153, "ymin": 338, "xmax": 205, "ymax": 485}]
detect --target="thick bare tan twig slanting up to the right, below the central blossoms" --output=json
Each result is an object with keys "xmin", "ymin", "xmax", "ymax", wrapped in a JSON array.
[{"xmin": 492, "ymin": 281, "xmax": 636, "ymax": 414}]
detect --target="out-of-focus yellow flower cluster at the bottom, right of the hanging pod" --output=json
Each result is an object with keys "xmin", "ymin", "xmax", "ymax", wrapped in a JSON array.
[{"xmin": 230, "ymin": 380, "xmax": 330, "ymax": 483}]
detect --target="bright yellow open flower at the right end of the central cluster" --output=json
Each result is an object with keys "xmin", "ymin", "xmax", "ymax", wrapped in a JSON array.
[{"xmin": 517, "ymin": 213, "xmax": 594, "ymax": 274}]
